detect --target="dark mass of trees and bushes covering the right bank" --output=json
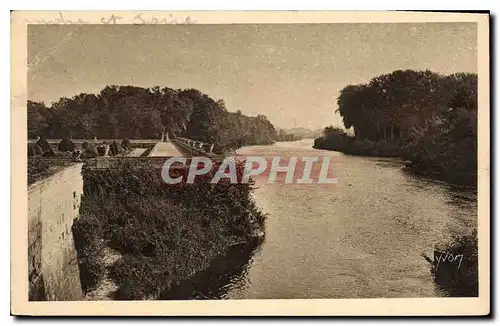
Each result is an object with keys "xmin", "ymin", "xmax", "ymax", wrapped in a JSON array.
[{"xmin": 317, "ymin": 70, "xmax": 478, "ymax": 185}]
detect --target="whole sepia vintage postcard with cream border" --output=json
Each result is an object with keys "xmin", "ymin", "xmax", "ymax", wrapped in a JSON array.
[{"xmin": 11, "ymin": 11, "xmax": 490, "ymax": 316}]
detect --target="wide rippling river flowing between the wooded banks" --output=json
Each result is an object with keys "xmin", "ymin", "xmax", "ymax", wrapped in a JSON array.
[{"xmin": 162, "ymin": 140, "xmax": 477, "ymax": 299}]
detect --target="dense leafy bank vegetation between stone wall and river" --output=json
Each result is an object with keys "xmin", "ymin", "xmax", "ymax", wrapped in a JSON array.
[{"xmin": 73, "ymin": 159, "xmax": 265, "ymax": 300}]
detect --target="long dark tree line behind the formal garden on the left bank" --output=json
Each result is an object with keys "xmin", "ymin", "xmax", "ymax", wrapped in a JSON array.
[{"xmin": 28, "ymin": 85, "xmax": 276, "ymax": 151}]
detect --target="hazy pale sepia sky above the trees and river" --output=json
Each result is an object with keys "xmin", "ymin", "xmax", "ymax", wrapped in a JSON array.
[{"xmin": 28, "ymin": 23, "xmax": 477, "ymax": 129}]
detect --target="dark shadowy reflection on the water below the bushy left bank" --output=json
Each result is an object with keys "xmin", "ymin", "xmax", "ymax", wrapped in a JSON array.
[{"xmin": 161, "ymin": 243, "xmax": 262, "ymax": 300}]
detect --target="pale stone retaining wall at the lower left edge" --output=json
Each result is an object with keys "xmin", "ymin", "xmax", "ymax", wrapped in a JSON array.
[{"xmin": 28, "ymin": 163, "xmax": 83, "ymax": 301}]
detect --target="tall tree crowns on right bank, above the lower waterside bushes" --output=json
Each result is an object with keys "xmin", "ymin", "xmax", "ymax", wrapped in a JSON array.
[{"xmin": 337, "ymin": 70, "xmax": 477, "ymax": 140}]
